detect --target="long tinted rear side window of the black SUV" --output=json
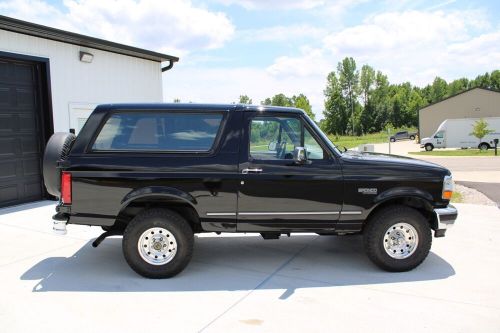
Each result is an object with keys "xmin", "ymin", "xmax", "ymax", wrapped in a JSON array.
[{"xmin": 92, "ymin": 112, "xmax": 222, "ymax": 151}]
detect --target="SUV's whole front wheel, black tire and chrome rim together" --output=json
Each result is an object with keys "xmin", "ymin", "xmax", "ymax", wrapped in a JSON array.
[{"xmin": 363, "ymin": 206, "xmax": 432, "ymax": 272}]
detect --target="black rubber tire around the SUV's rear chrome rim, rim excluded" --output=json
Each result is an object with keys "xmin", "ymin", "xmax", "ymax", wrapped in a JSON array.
[{"xmin": 122, "ymin": 208, "xmax": 194, "ymax": 279}]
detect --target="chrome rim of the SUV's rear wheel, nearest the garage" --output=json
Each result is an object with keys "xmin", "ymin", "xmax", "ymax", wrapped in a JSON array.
[{"xmin": 137, "ymin": 228, "xmax": 177, "ymax": 265}]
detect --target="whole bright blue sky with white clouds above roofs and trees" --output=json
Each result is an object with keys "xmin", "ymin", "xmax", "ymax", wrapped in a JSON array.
[{"xmin": 0, "ymin": 0, "xmax": 500, "ymax": 117}]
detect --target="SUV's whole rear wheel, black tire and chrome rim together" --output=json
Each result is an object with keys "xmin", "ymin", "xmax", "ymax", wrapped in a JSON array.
[{"xmin": 122, "ymin": 209, "xmax": 194, "ymax": 279}]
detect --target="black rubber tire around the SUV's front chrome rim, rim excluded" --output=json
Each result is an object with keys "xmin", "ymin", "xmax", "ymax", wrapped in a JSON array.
[{"xmin": 363, "ymin": 206, "xmax": 432, "ymax": 272}]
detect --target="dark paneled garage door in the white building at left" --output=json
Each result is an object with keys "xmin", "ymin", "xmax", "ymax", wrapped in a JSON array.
[{"xmin": 0, "ymin": 58, "xmax": 43, "ymax": 207}]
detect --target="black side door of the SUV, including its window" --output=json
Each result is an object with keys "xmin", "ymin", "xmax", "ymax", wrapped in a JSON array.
[{"xmin": 237, "ymin": 112, "xmax": 343, "ymax": 232}]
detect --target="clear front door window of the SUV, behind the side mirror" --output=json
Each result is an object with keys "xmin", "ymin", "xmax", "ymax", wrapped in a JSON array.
[{"xmin": 250, "ymin": 117, "xmax": 325, "ymax": 160}]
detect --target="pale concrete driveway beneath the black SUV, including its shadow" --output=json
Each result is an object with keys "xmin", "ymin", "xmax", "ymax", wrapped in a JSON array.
[{"xmin": 0, "ymin": 202, "xmax": 500, "ymax": 333}]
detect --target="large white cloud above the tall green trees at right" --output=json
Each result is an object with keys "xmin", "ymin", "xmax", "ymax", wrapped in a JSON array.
[{"xmin": 268, "ymin": 10, "xmax": 500, "ymax": 90}]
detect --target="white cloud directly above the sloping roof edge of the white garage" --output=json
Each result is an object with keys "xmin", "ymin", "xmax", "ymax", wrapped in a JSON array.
[{"xmin": 0, "ymin": 0, "xmax": 235, "ymax": 55}]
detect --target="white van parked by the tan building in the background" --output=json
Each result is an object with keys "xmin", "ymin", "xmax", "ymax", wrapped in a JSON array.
[{"xmin": 420, "ymin": 117, "xmax": 500, "ymax": 151}]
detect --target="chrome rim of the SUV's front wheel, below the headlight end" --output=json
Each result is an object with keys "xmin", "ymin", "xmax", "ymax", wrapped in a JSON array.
[{"xmin": 383, "ymin": 222, "xmax": 418, "ymax": 259}]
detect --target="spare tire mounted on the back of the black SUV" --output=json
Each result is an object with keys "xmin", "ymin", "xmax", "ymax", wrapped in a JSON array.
[{"xmin": 43, "ymin": 132, "xmax": 76, "ymax": 197}]
